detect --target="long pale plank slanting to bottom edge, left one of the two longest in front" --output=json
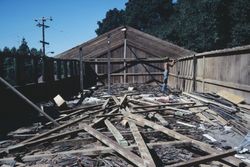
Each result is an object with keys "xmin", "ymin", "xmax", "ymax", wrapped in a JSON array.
[{"xmin": 78, "ymin": 124, "xmax": 144, "ymax": 166}]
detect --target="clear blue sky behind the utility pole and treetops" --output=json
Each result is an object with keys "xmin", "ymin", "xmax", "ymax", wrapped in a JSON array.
[{"xmin": 0, "ymin": 0, "xmax": 128, "ymax": 55}]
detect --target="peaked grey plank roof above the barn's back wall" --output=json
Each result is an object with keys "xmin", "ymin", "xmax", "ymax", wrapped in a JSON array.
[{"xmin": 56, "ymin": 26, "xmax": 194, "ymax": 59}]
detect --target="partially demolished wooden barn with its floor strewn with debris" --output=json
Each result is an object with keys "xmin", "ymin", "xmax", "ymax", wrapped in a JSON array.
[{"xmin": 0, "ymin": 26, "xmax": 250, "ymax": 167}]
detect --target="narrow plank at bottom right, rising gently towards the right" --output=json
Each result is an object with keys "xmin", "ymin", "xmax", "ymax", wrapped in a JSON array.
[{"xmin": 169, "ymin": 149, "xmax": 236, "ymax": 167}]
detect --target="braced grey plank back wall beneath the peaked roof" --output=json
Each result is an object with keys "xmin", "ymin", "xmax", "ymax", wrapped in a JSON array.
[{"xmin": 88, "ymin": 46, "xmax": 163, "ymax": 83}]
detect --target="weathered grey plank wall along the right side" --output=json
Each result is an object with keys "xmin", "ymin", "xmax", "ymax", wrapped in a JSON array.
[{"xmin": 170, "ymin": 46, "xmax": 250, "ymax": 103}]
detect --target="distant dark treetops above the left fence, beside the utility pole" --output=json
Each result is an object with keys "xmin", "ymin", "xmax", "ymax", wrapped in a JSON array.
[{"xmin": 0, "ymin": 38, "xmax": 42, "ymax": 56}]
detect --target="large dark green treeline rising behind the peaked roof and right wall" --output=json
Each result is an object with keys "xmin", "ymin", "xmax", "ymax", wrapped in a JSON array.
[{"xmin": 96, "ymin": 0, "xmax": 250, "ymax": 52}]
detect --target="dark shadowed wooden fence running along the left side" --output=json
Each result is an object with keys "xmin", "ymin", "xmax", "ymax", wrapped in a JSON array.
[{"xmin": 0, "ymin": 55, "xmax": 79, "ymax": 86}]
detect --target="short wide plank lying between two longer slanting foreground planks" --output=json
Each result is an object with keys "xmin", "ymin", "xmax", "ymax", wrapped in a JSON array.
[{"xmin": 104, "ymin": 119, "xmax": 128, "ymax": 146}]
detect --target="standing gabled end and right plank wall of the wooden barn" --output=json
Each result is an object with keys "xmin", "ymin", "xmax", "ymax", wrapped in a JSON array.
[{"xmin": 57, "ymin": 26, "xmax": 250, "ymax": 103}]
